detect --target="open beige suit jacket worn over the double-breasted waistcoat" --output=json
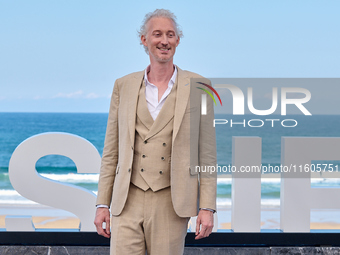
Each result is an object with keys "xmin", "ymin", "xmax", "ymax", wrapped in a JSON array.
[{"xmin": 97, "ymin": 67, "xmax": 216, "ymax": 217}]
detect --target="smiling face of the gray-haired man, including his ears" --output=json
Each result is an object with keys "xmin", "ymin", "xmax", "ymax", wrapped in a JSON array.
[{"xmin": 141, "ymin": 17, "xmax": 179, "ymax": 63}]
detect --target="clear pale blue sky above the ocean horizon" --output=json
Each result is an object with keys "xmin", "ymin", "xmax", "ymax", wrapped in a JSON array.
[{"xmin": 0, "ymin": 0, "xmax": 340, "ymax": 112}]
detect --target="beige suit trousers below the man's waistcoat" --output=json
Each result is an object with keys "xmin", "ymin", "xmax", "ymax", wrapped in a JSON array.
[{"xmin": 110, "ymin": 183, "xmax": 190, "ymax": 255}]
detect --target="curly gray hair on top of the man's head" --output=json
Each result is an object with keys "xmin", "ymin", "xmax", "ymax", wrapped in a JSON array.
[{"xmin": 138, "ymin": 9, "xmax": 183, "ymax": 54}]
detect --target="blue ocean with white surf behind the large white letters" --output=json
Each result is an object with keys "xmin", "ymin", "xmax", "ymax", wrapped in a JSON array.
[{"xmin": 0, "ymin": 113, "xmax": 340, "ymax": 208}]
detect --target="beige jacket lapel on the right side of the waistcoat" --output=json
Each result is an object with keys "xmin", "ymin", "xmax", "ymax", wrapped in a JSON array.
[{"xmin": 172, "ymin": 66, "xmax": 190, "ymax": 142}]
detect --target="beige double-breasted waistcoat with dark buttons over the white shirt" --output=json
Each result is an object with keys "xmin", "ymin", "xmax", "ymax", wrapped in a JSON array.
[{"xmin": 131, "ymin": 81, "xmax": 177, "ymax": 192}]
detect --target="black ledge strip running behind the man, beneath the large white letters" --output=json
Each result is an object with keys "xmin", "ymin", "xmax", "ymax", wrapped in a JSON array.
[{"xmin": 0, "ymin": 231, "xmax": 340, "ymax": 248}]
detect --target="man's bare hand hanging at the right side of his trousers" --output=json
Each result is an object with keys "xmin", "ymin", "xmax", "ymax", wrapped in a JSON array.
[{"xmin": 195, "ymin": 210, "xmax": 214, "ymax": 240}]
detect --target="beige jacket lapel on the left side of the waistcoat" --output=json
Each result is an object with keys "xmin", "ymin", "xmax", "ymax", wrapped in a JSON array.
[{"xmin": 127, "ymin": 71, "xmax": 144, "ymax": 148}]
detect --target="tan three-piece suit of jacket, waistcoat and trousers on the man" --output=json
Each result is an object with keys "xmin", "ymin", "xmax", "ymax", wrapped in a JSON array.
[{"xmin": 97, "ymin": 67, "xmax": 216, "ymax": 254}]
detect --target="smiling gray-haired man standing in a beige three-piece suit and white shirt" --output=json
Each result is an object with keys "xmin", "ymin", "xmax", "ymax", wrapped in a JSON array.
[{"xmin": 95, "ymin": 9, "xmax": 216, "ymax": 255}]
